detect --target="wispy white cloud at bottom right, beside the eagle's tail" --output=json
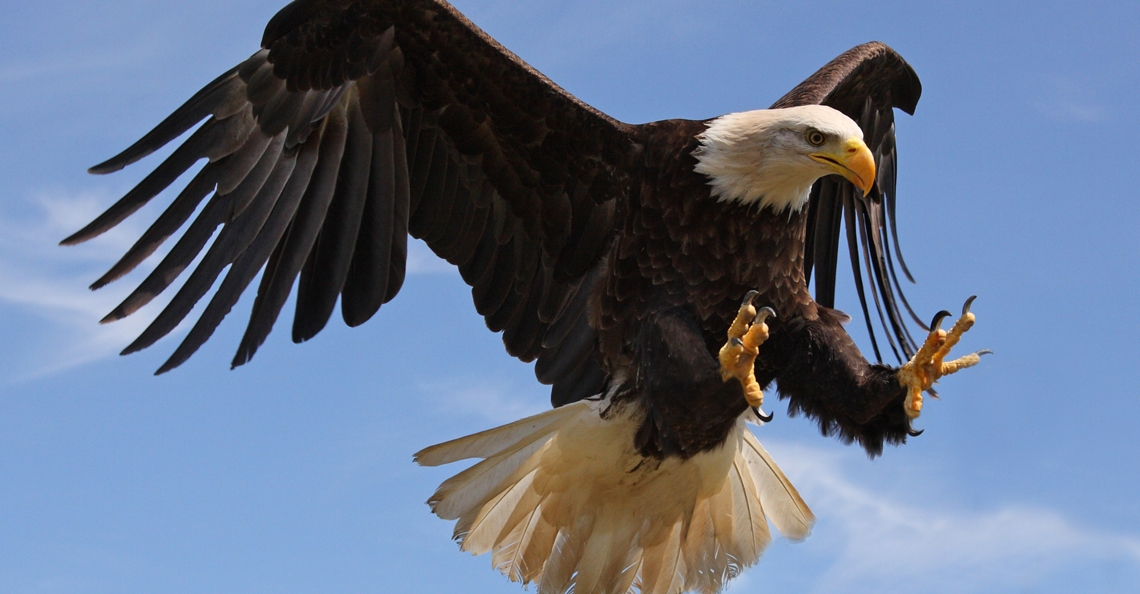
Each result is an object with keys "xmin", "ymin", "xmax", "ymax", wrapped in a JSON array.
[{"xmin": 756, "ymin": 445, "xmax": 1140, "ymax": 593}]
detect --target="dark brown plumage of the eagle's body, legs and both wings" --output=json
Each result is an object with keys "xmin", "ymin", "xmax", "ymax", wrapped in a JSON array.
[{"xmin": 64, "ymin": 0, "xmax": 921, "ymax": 456}]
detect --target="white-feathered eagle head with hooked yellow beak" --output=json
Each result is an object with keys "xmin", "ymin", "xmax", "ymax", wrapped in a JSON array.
[{"xmin": 693, "ymin": 105, "xmax": 876, "ymax": 212}]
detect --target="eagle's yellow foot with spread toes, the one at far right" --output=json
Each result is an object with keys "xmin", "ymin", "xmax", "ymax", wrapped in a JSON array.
[{"xmin": 898, "ymin": 296, "xmax": 992, "ymax": 436}]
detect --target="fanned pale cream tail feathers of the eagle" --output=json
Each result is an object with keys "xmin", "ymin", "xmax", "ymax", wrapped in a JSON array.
[{"xmin": 416, "ymin": 400, "xmax": 814, "ymax": 594}]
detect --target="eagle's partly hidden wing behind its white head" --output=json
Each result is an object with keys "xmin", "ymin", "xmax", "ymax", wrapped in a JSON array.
[{"xmin": 773, "ymin": 42, "xmax": 926, "ymax": 361}]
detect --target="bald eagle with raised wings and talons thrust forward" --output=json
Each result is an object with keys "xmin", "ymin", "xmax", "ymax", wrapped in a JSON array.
[{"xmin": 63, "ymin": 0, "xmax": 979, "ymax": 594}]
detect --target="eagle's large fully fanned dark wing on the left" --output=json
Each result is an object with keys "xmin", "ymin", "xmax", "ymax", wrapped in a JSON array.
[{"xmin": 63, "ymin": 0, "xmax": 634, "ymax": 399}]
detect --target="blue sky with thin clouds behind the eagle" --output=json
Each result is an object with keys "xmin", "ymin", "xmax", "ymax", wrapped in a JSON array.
[{"xmin": 0, "ymin": 0, "xmax": 1140, "ymax": 594}]
